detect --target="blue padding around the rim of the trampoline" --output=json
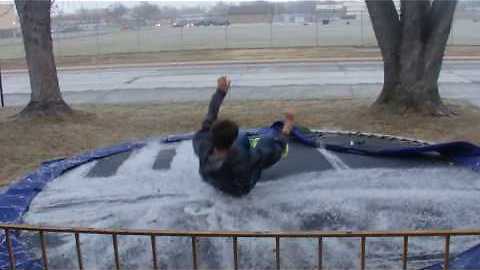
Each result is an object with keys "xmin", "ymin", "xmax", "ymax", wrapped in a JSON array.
[{"xmin": 0, "ymin": 122, "xmax": 480, "ymax": 270}]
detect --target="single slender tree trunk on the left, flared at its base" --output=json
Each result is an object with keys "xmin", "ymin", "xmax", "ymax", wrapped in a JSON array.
[{"xmin": 15, "ymin": 0, "xmax": 72, "ymax": 117}]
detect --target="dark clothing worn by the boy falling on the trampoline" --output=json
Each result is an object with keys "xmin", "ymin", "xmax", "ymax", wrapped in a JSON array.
[{"xmin": 193, "ymin": 90, "xmax": 286, "ymax": 197}]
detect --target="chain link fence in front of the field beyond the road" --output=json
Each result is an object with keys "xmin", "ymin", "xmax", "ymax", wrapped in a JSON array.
[{"xmin": 0, "ymin": 1, "xmax": 480, "ymax": 59}]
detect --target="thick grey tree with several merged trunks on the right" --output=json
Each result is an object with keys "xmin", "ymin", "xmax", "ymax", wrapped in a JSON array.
[{"xmin": 365, "ymin": 0, "xmax": 457, "ymax": 115}]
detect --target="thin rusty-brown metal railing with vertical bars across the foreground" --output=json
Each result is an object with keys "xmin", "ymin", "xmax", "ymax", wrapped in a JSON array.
[{"xmin": 0, "ymin": 224, "xmax": 480, "ymax": 270}]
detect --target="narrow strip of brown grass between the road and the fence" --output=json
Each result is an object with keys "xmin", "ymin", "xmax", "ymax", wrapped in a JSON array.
[{"xmin": 0, "ymin": 46, "xmax": 480, "ymax": 72}]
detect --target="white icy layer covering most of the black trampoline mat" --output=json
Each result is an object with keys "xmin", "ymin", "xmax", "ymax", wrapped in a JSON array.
[{"xmin": 25, "ymin": 141, "xmax": 480, "ymax": 269}]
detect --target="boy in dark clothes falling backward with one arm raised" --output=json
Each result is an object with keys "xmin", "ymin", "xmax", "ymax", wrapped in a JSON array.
[{"xmin": 193, "ymin": 77, "xmax": 294, "ymax": 197}]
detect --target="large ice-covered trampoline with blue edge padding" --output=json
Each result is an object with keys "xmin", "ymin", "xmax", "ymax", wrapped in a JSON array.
[{"xmin": 0, "ymin": 124, "xmax": 480, "ymax": 269}]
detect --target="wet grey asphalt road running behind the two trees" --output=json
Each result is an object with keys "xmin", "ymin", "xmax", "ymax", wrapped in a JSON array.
[{"xmin": 3, "ymin": 61, "xmax": 480, "ymax": 106}]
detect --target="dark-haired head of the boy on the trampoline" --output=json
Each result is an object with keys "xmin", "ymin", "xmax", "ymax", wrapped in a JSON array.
[{"xmin": 210, "ymin": 120, "xmax": 238, "ymax": 150}]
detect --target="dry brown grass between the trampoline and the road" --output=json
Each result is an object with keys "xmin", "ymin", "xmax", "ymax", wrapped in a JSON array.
[{"xmin": 0, "ymin": 99, "xmax": 480, "ymax": 185}]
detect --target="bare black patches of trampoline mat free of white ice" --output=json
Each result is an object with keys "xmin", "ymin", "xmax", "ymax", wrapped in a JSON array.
[{"xmin": 87, "ymin": 134, "xmax": 451, "ymax": 181}]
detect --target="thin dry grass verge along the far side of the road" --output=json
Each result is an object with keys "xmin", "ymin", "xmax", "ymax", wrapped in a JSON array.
[{"xmin": 2, "ymin": 46, "xmax": 480, "ymax": 70}]
